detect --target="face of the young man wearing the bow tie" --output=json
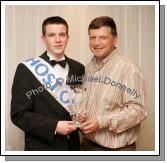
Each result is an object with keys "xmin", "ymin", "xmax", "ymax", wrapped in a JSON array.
[{"xmin": 42, "ymin": 24, "xmax": 69, "ymax": 57}]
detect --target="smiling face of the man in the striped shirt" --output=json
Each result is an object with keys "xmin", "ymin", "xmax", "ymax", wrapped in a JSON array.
[{"xmin": 89, "ymin": 26, "xmax": 117, "ymax": 60}]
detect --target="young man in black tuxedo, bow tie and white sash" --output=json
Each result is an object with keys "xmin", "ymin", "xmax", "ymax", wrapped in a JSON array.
[{"xmin": 11, "ymin": 16, "xmax": 85, "ymax": 151}]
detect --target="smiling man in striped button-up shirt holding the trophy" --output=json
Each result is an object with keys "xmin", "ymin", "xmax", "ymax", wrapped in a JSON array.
[{"xmin": 81, "ymin": 16, "xmax": 146, "ymax": 151}]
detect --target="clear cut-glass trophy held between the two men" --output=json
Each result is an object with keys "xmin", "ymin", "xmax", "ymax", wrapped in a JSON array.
[{"xmin": 68, "ymin": 85, "xmax": 86, "ymax": 127}]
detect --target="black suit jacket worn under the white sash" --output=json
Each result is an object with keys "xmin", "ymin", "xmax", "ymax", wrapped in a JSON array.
[{"xmin": 11, "ymin": 52, "xmax": 85, "ymax": 151}]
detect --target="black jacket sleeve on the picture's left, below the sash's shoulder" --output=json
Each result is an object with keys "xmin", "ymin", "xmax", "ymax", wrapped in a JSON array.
[{"xmin": 11, "ymin": 64, "xmax": 58, "ymax": 143}]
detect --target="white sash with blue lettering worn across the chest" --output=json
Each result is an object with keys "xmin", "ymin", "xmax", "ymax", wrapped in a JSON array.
[{"xmin": 23, "ymin": 57, "xmax": 69, "ymax": 111}]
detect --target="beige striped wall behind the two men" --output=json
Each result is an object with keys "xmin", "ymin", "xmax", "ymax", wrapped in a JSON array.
[{"xmin": 5, "ymin": 6, "xmax": 155, "ymax": 150}]
